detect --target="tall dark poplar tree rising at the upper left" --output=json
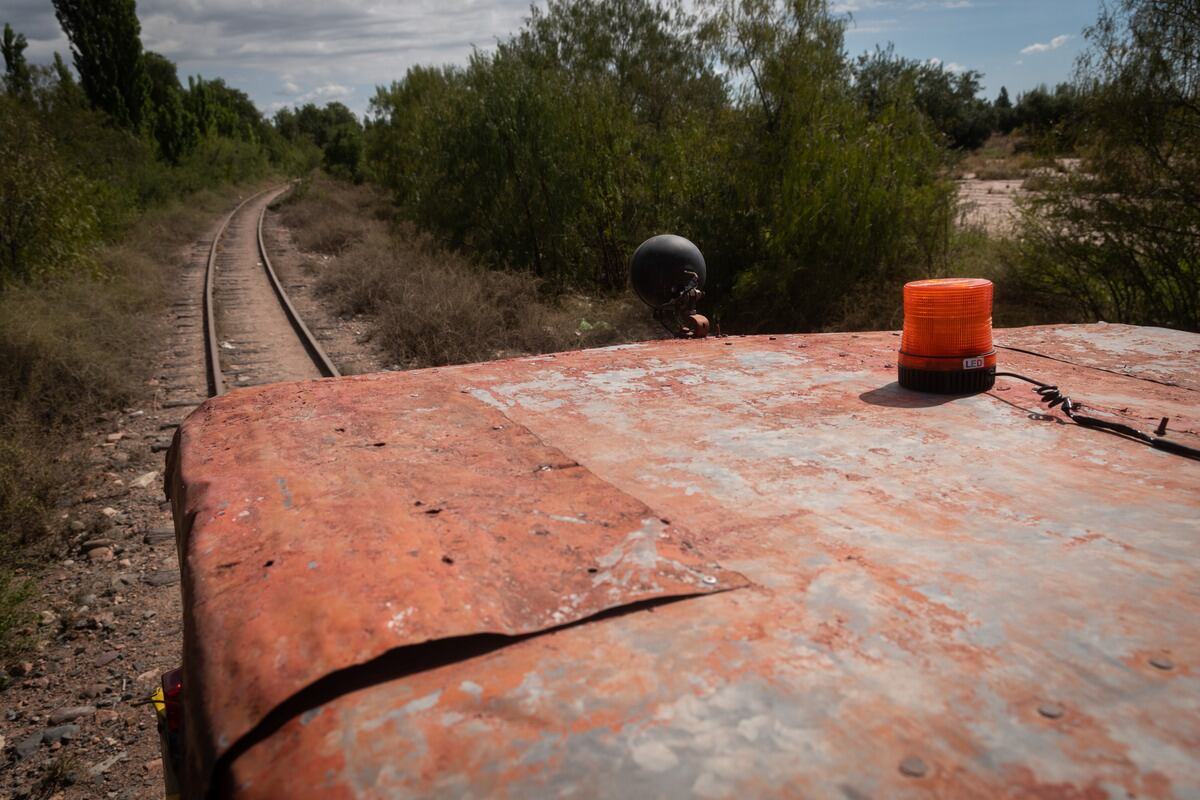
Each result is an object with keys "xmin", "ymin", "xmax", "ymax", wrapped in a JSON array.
[{"xmin": 54, "ymin": 0, "xmax": 150, "ymax": 130}]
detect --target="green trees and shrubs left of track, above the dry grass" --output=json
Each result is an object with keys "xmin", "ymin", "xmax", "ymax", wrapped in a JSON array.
[{"xmin": 0, "ymin": 9, "xmax": 282, "ymax": 287}]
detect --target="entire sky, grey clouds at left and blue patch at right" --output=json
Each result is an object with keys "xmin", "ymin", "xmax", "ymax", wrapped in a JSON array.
[{"xmin": 0, "ymin": 0, "xmax": 1099, "ymax": 114}]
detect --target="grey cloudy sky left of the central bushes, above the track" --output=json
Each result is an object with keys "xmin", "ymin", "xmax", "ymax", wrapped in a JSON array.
[{"xmin": 0, "ymin": 0, "xmax": 535, "ymax": 110}]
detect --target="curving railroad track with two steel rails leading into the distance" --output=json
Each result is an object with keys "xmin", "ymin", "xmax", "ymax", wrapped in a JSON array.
[{"xmin": 203, "ymin": 187, "xmax": 340, "ymax": 396}]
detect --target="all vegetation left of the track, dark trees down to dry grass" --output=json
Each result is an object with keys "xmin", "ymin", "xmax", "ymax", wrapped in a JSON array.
[{"xmin": 0, "ymin": 0, "xmax": 298, "ymax": 652}]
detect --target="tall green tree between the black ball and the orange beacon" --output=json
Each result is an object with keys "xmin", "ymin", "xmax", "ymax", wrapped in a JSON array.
[{"xmin": 710, "ymin": 0, "xmax": 953, "ymax": 331}]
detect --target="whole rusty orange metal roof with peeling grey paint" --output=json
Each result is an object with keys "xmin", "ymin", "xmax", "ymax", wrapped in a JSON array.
[{"xmin": 170, "ymin": 325, "xmax": 1200, "ymax": 798}]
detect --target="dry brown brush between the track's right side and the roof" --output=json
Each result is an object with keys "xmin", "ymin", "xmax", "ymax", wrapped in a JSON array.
[{"xmin": 282, "ymin": 180, "xmax": 661, "ymax": 367}]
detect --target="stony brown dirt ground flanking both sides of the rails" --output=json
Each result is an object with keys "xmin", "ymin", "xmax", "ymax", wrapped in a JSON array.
[{"xmin": 0, "ymin": 190, "xmax": 382, "ymax": 800}]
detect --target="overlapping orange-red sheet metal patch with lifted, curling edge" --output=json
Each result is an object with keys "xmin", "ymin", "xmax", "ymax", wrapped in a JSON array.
[{"xmin": 169, "ymin": 375, "xmax": 745, "ymax": 796}]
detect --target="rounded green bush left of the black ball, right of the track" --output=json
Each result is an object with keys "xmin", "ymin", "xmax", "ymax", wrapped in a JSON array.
[{"xmin": 367, "ymin": 0, "xmax": 722, "ymax": 289}]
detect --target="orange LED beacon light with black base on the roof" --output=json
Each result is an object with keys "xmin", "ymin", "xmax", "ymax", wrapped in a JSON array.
[{"xmin": 899, "ymin": 278, "xmax": 996, "ymax": 395}]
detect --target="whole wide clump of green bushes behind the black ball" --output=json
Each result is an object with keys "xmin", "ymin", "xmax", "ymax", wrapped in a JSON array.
[{"xmin": 366, "ymin": 0, "xmax": 954, "ymax": 331}]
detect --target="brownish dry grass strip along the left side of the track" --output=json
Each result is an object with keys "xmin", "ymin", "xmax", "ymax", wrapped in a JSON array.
[{"xmin": 0, "ymin": 181, "xmax": 270, "ymax": 650}]
